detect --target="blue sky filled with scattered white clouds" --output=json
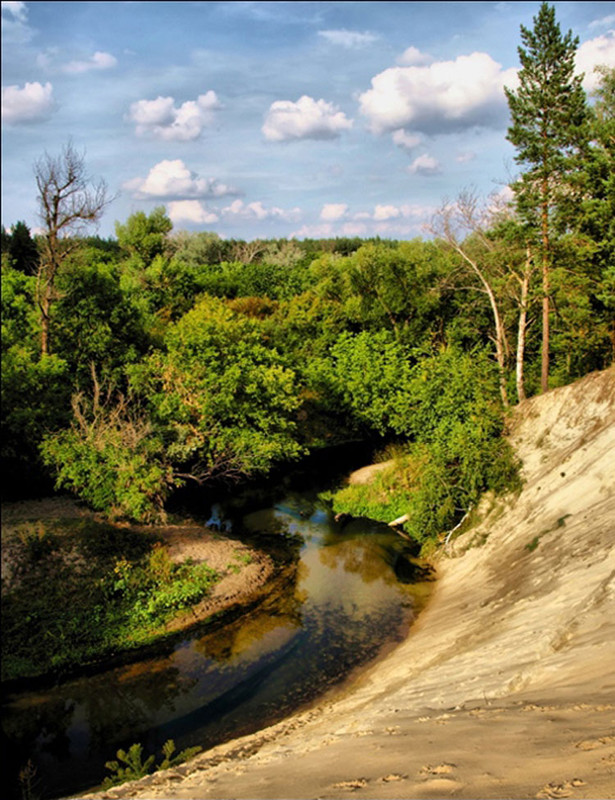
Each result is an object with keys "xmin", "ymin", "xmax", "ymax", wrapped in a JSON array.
[{"xmin": 2, "ymin": 0, "xmax": 615, "ymax": 240}]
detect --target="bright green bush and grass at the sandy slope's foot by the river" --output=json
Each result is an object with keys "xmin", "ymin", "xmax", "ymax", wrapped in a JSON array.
[{"xmin": 334, "ymin": 348, "xmax": 518, "ymax": 542}]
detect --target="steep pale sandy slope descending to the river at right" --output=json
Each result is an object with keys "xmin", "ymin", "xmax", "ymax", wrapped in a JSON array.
[{"xmin": 85, "ymin": 369, "xmax": 615, "ymax": 798}]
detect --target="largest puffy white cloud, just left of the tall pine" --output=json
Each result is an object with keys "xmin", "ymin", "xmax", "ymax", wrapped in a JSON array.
[{"xmin": 359, "ymin": 53, "xmax": 517, "ymax": 134}]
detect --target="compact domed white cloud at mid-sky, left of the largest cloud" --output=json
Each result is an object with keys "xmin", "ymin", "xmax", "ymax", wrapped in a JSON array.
[{"xmin": 262, "ymin": 95, "xmax": 352, "ymax": 142}]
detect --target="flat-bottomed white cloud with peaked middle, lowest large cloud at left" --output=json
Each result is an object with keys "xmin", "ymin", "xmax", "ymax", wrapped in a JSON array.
[{"xmin": 124, "ymin": 159, "xmax": 239, "ymax": 199}]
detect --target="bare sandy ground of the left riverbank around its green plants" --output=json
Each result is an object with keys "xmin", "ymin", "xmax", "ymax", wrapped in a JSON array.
[{"xmin": 2, "ymin": 497, "xmax": 284, "ymax": 690}]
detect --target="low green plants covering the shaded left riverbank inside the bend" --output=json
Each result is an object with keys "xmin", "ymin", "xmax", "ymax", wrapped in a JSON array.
[{"xmin": 2, "ymin": 521, "xmax": 218, "ymax": 680}]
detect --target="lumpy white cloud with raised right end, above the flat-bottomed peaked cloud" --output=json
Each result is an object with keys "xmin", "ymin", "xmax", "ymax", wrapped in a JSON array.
[{"xmin": 129, "ymin": 89, "xmax": 222, "ymax": 142}]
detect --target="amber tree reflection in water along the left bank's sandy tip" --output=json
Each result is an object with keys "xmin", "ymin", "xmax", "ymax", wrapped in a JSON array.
[{"xmin": 194, "ymin": 562, "xmax": 309, "ymax": 662}]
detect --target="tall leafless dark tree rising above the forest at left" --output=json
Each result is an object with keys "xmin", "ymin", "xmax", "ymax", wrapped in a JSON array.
[{"xmin": 34, "ymin": 142, "xmax": 111, "ymax": 354}]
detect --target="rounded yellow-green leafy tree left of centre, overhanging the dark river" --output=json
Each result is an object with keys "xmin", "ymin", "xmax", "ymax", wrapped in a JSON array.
[{"xmin": 132, "ymin": 298, "xmax": 300, "ymax": 475}]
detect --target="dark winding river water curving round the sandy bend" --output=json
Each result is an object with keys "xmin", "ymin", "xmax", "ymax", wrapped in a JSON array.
[{"xmin": 3, "ymin": 472, "xmax": 434, "ymax": 797}]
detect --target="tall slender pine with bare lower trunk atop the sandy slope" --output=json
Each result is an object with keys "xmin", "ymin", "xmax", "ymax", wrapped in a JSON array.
[{"xmin": 506, "ymin": 2, "xmax": 587, "ymax": 391}]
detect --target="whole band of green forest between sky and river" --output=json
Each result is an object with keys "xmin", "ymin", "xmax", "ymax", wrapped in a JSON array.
[{"xmin": 2, "ymin": 6, "xmax": 615, "ymax": 539}]
